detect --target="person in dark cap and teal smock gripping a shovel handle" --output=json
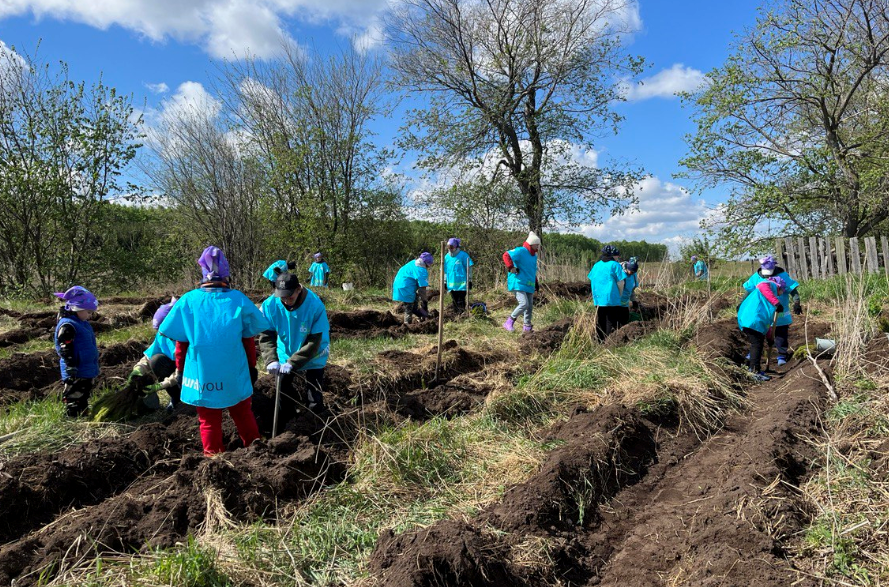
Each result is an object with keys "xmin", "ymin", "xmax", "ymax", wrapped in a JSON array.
[{"xmin": 259, "ymin": 273, "xmax": 330, "ymax": 429}]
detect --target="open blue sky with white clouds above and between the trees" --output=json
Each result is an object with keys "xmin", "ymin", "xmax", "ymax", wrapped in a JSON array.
[{"xmin": 0, "ymin": 0, "xmax": 759, "ymax": 245}]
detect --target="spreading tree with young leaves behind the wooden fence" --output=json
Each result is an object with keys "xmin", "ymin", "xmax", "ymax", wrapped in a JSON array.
[{"xmin": 683, "ymin": 0, "xmax": 889, "ymax": 251}]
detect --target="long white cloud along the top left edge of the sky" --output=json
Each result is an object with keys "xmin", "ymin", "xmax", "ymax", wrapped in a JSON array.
[{"xmin": 0, "ymin": 0, "xmax": 389, "ymax": 58}]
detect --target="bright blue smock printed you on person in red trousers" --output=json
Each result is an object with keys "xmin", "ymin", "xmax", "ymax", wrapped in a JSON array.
[{"xmin": 158, "ymin": 288, "xmax": 271, "ymax": 409}]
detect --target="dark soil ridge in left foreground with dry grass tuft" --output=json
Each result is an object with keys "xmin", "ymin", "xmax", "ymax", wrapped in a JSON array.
[{"xmin": 0, "ymin": 433, "xmax": 344, "ymax": 585}]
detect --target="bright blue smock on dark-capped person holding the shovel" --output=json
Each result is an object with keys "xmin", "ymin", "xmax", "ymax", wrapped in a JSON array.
[{"xmin": 262, "ymin": 290, "xmax": 330, "ymax": 371}]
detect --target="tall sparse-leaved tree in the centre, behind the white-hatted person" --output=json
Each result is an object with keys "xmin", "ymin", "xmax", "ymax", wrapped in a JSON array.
[{"xmin": 389, "ymin": 0, "xmax": 641, "ymax": 232}]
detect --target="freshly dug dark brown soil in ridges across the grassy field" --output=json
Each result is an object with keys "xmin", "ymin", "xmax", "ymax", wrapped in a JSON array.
[{"xmin": 0, "ymin": 292, "xmax": 848, "ymax": 586}]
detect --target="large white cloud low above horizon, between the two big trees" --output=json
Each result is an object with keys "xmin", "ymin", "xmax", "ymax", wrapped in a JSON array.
[{"xmin": 580, "ymin": 177, "xmax": 710, "ymax": 245}]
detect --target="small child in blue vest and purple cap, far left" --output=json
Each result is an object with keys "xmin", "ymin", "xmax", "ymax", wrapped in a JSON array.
[{"xmin": 54, "ymin": 285, "xmax": 99, "ymax": 418}]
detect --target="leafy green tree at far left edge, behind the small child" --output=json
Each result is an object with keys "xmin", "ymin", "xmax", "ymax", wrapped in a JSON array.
[{"xmin": 0, "ymin": 49, "xmax": 142, "ymax": 293}]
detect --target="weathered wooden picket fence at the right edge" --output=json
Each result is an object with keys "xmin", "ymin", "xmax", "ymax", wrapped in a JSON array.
[{"xmin": 775, "ymin": 236, "xmax": 889, "ymax": 280}]
